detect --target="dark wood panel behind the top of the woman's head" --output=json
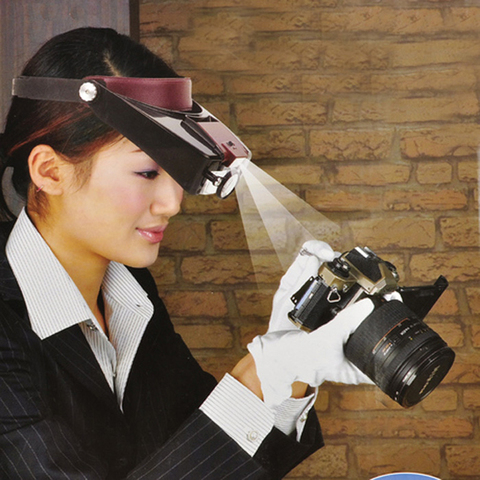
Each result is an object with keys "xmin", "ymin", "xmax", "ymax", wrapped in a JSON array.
[{"xmin": 0, "ymin": 0, "xmax": 139, "ymax": 126}]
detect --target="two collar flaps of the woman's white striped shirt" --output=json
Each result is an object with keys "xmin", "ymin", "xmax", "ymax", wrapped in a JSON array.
[{"xmin": 6, "ymin": 209, "xmax": 153, "ymax": 340}]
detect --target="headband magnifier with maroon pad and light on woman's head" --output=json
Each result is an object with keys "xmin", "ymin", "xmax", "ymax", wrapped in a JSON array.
[{"xmin": 12, "ymin": 77, "xmax": 251, "ymax": 198}]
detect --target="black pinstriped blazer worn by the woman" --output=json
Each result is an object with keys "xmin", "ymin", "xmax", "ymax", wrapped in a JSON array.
[{"xmin": 0, "ymin": 224, "xmax": 323, "ymax": 480}]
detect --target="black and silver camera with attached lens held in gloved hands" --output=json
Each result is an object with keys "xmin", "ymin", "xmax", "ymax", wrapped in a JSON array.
[{"xmin": 289, "ymin": 247, "xmax": 455, "ymax": 407}]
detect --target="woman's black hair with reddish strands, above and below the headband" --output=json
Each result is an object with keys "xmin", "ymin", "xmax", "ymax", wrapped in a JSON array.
[{"xmin": 0, "ymin": 27, "xmax": 178, "ymax": 218}]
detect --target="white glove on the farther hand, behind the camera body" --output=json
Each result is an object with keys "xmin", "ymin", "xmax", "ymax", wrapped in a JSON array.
[{"xmin": 268, "ymin": 240, "xmax": 335, "ymax": 332}]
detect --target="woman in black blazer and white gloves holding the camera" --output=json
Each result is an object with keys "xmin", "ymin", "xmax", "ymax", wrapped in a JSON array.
[{"xmin": 0, "ymin": 28, "xmax": 371, "ymax": 480}]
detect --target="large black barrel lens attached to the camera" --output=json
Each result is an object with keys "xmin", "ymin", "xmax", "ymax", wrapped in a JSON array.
[{"xmin": 345, "ymin": 300, "xmax": 455, "ymax": 407}]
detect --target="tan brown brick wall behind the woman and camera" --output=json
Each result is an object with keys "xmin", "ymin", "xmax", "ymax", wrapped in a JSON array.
[{"xmin": 140, "ymin": 0, "xmax": 480, "ymax": 480}]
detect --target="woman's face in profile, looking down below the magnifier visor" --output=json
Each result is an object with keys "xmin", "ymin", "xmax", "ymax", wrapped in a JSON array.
[{"xmin": 55, "ymin": 139, "xmax": 183, "ymax": 267}]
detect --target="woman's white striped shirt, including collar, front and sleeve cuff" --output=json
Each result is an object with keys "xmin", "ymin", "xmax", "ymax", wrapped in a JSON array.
[{"xmin": 6, "ymin": 210, "xmax": 315, "ymax": 455}]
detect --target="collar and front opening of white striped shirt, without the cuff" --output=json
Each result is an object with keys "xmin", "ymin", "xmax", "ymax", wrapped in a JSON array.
[{"xmin": 6, "ymin": 210, "xmax": 153, "ymax": 405}]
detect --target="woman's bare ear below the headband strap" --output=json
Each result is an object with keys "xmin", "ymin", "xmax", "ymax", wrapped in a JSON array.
[{"xmin": 28, "ymin": 145, "xmax": 66, "ymax": 195}]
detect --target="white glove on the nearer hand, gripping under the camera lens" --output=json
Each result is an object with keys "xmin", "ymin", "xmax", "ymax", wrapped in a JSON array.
[{"xmin": 248, "ymin": 298, "xmax": 373, "ymax": 408}]
